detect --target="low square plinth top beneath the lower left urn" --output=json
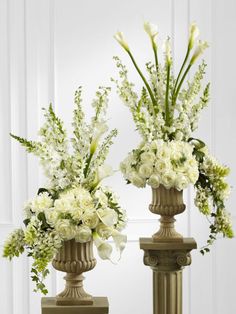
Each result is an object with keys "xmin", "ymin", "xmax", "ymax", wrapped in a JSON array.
[{"xmin": 41, "ymin": 297, "xmax": 109, "ymax": 314}]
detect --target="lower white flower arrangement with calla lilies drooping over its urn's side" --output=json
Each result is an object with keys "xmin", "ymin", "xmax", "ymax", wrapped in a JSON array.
[{"xmin": 4, "ymin": 87, "xmax": 126, "ymax": 294}]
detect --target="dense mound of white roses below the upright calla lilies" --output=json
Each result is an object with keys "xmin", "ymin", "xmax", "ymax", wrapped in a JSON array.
[{"xmin": 120, "ymin": 140, "xmax": 199, "ymax": 191}]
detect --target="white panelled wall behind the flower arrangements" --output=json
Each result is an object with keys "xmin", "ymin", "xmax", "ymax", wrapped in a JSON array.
[{"xmin": 0, "ymin": 0, "xmax": 236, "ymax": 314}]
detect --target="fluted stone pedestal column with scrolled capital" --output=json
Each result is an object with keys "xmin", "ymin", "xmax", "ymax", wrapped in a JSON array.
[{"xmin": 140, "ymin": 238, "xmax": 197, "ymax": 314}]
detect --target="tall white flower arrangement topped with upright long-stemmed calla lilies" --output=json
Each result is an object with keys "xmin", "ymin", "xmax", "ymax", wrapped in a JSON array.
[{"xmin": 112, "ymin": 22, "xmax": 233, "ymax": 254}]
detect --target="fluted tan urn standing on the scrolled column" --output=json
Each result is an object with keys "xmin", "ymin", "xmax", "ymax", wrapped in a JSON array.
[{"xmin": 149, "ymin": 185, "xmax": 186, "ymax": 242}]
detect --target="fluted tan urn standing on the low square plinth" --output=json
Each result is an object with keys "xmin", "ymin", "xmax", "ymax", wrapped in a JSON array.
[{"xmin": 52, "ymin": 239, "xmax": 96, "ymax": 305}]
